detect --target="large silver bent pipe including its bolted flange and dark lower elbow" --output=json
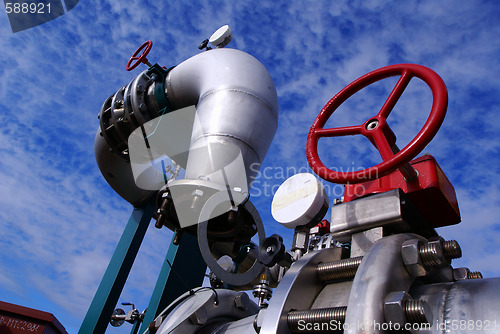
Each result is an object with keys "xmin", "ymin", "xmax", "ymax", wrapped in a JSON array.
[{"xmin": 95, "ymin": 49, "xmax": 278, "ymax": 205}]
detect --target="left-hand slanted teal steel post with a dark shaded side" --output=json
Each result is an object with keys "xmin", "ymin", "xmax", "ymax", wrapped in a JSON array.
[{"xmin": 78, "ymin": 202, "xmax": 155, "ymax": 334}]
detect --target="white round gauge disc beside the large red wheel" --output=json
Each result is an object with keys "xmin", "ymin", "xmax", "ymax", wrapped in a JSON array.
[{"xmin": 271, "ymin": 173, "xmax": 328, "ymax": 229}]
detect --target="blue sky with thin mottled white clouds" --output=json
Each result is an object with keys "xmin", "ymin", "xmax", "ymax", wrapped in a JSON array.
[{"xmin": 0, "ymin": 0, "xmax": 500, "ymax": 333}]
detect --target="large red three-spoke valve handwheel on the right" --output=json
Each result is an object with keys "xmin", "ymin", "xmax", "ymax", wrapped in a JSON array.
[{"xmin": 306, "ymin": 64, "xmax": 448, "ymax": 183}]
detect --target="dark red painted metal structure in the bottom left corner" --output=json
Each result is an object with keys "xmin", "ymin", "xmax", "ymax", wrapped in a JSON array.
[{"xmin": 0, "ymin": 301, "xmax": 68, "ymax": 334}]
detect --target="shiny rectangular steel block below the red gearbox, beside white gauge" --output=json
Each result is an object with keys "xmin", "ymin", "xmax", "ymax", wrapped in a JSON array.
[{"xmin": 330, "ymin": 189, "xmax": 409, "ymax": 241}]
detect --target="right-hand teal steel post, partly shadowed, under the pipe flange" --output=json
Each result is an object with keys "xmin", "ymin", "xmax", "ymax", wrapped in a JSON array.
[{"xmin": 139, "ymin": 233, "xmax": 207, "ymax": 333}]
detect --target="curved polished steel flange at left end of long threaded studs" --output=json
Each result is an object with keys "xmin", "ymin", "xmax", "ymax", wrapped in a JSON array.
[{"xmin": 260, "ymin": 248, "xmax": 342, "ymax": 334}]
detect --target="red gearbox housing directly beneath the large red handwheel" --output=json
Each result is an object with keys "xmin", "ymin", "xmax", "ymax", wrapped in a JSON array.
[{"xmin": 344, "ymin": 155, "xmax": 461, "ymax": 227}]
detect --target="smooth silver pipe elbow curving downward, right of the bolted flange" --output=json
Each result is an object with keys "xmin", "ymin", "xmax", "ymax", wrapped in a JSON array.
[{"xmin": 166, "ymin": 49, "xmax": 278, "ymax": 192}]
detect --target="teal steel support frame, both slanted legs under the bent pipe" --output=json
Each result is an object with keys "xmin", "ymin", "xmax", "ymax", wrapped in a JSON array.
[{"xmin": 78, "ymin": 201, "xmax": 206, "ymax": 334}]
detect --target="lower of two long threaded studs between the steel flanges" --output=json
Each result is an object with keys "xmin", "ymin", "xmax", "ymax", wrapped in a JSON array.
[{"xmin": 287, "ymin": 306, "xmax": 347, "ymax": 333}]
